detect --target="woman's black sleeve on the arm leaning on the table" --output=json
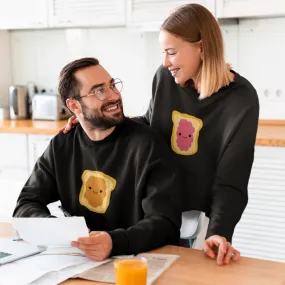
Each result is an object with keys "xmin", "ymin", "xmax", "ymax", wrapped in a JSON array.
[{"xmin": 206, "ymin": 106, "xmax": 259, "ymax": 242}]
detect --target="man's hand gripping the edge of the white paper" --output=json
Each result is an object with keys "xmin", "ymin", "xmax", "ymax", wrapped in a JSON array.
[{"xmin": 71, "ymin": 232, "xmax": 113, "ymax": 261}]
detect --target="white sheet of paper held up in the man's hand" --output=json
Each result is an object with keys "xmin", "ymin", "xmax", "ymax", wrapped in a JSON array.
[{"xmin": 13, "ymin": 217, "xmax": 89, "ymax": 246}]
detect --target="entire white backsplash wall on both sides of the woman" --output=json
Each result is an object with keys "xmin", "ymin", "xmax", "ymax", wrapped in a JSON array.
[{"xmin": 8, "ymin": 17, "xmax": 285, "ymax": 117}]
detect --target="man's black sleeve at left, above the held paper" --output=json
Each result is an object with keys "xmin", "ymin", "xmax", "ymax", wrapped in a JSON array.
[{"xmin": 13, "ymin": 141, "xmax": 59, "ymax": 217}]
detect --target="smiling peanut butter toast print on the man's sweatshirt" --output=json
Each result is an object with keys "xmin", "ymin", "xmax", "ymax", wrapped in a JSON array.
[{"xmin": 79, "ymin": 170, "xmax": 116, "ymax": 214}]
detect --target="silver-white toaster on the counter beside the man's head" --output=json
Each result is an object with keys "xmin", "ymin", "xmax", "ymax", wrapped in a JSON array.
[{"xmin": 32, "ymin": 93, "xmax": 71, "ymax": 121}]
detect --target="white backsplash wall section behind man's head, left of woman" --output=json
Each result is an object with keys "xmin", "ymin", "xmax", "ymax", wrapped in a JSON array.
[{"xmin": 11, "ymin": 28, "xmax": 153, "ymax": 116}]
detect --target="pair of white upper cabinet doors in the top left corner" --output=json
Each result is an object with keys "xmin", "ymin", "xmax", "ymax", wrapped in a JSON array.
[{"xmin": 0, "ymin": 0, "xmax": 126, "ymax": 30}]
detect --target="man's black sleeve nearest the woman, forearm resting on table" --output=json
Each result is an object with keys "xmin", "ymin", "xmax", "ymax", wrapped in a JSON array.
[{"xmin": 109, "ymin": 134, "xmax": 181, "ymax": 255}]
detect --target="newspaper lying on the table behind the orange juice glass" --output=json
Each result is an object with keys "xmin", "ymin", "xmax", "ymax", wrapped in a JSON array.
[{"xmin": 76, "ymin": 253, "xmax": 179, "ymax": 285}]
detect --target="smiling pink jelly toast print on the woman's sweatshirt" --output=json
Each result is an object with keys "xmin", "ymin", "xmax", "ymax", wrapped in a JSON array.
[{"xmin": 171, "ymin": 111, "xmax": 203, "ymax": 155}]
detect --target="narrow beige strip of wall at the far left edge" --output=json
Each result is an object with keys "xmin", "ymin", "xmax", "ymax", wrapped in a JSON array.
[{"xmin": 0, "ymin": 30, "xmax": 11, "ymax": 107}]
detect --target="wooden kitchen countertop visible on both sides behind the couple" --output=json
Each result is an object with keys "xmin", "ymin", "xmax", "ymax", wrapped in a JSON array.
[{"xmin": 0, "ymin": 120, "xmax": 285, "ymax": 147}]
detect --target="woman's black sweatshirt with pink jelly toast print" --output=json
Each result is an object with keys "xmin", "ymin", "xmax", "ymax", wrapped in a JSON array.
[{"xmin": 135, "ymin": 66, "xmax": 259, "ymax": 241}]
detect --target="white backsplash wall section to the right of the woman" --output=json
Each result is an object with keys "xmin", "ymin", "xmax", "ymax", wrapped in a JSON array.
[{"xmin": 239, "ymin": 18, "xmax": 285, "ymax": 120}]
